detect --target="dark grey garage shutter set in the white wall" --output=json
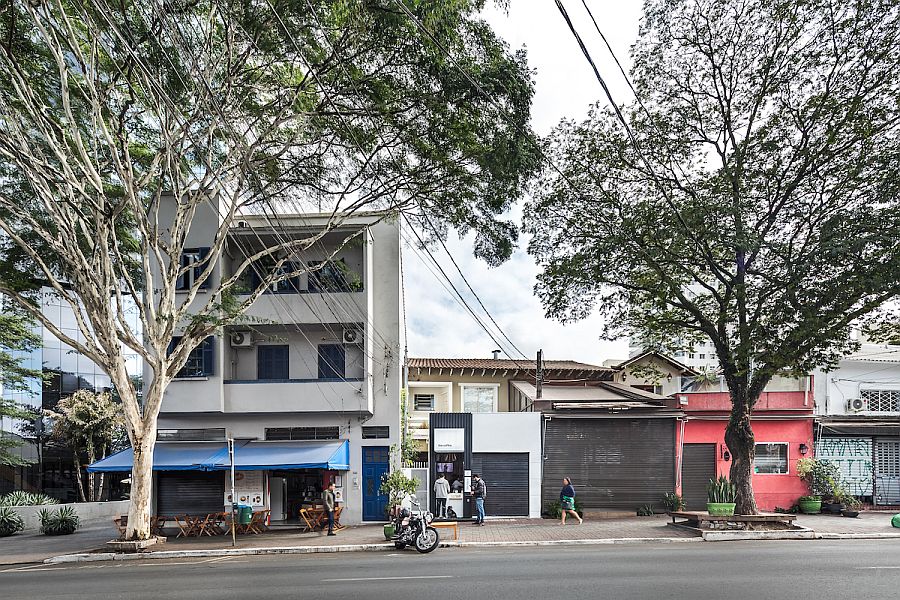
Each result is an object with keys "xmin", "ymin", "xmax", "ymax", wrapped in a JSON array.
[{"xmin": 472, "ymin": 452, "xmax": 528, "ymax": 517}]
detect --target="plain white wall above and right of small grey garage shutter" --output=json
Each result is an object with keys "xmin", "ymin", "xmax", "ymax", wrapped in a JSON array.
[{"xmin": 472, "ymin": 413, "xmax": 543, "ymax": 519}]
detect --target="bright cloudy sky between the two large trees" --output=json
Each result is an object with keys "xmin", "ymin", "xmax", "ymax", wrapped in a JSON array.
[{"xmin": 403, "ymin": 0, "xmax": 641, "ymax": 364}]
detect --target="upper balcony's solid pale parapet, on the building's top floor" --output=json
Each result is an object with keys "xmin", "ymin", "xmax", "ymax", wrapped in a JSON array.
[{"xmin": 239, "ymin": 292, "xmax": 366, "ymax": 323}]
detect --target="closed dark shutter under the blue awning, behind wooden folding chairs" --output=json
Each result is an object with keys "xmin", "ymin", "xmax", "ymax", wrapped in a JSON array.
[{"xmin": 156, "ymin": 471, "xmax": 225, "ymax": 517}]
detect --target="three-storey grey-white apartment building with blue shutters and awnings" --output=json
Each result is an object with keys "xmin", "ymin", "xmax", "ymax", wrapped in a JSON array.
[{"xmin": 94, "ymin": 199, "xmax": 403, "ymax": 524}]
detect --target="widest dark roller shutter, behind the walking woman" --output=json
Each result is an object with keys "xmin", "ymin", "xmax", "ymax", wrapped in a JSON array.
[{"xmin": 541, "ymin": 418, "xmax": 675, "ymax": 510}]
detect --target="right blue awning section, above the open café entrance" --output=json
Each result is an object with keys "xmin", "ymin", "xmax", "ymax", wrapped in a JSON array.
[{"xmin": 215, "ymin": 440, "xmax": 350, "ymax": 471}]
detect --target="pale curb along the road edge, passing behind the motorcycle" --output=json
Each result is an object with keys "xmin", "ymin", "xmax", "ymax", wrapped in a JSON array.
[{"xmin": 43, "ymin": 537, "xmax": 702, "ymax": 564}]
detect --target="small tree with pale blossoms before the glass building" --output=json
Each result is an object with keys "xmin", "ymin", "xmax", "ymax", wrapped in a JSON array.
[{"xmin": 44, "ymin": 390, "xmax": 127, "ymax": 502}]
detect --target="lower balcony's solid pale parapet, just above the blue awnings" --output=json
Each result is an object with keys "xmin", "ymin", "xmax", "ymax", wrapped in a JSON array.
[{"xmin": 224, "ymin": 379, "xmax": 372, "ymax": 413}]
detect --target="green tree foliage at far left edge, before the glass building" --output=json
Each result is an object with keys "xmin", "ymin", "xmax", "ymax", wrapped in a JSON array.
[{"xmin": 0, "ymin": 307, "xmax": 41, "ymax": 466}]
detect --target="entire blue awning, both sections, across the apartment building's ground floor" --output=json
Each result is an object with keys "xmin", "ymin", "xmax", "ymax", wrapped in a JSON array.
[{"xmin": 88, "ymin": 440, "xmax": 350, "ymax": 473}]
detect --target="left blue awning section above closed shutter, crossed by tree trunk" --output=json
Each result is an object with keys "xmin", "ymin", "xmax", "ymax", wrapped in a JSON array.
[{"xmin": 87, "ymin": 442, "xmax": 228, "ymax": 473}]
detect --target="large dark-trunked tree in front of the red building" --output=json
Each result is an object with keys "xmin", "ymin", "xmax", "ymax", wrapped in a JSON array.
[{"xmin": 527, "ymin": 0, "xmax": 900, "ymax": 514}]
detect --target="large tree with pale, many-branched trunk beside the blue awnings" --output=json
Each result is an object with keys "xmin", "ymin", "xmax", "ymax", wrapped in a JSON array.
[{"xmin": 0, "ymin": 0, "xmax": 539, "ymax": 539}]
